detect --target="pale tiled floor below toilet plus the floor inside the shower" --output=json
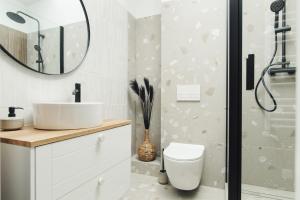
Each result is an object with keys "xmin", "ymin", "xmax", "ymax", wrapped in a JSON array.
[{"xmin": 121, "ymin": 173, "xmax": 294, "ymax": 200}]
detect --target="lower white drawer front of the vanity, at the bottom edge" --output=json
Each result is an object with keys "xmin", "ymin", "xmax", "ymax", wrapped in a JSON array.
[{"xmin": 57, "ymin": 159, "xmax": 130, "ymax": 200}]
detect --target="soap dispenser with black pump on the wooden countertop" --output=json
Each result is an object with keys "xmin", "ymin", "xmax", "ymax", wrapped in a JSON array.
[{"xmin": 0, "ymin": 107, "xmax": 24, "ymax": 131}]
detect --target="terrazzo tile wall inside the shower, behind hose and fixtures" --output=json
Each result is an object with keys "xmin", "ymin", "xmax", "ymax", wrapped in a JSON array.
[{"xmin": 243, "ymin": 0, "xmax": 296, "ymax": 191}]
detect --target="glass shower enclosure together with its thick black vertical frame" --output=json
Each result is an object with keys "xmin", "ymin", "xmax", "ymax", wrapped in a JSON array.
[{"xmin": 227, "ymin": 0, "xmax": 297, "ymax": 200}]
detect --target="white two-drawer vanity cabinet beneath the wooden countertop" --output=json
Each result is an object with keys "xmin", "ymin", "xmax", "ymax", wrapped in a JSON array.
[{"xmin": 1, "ymin": 125, "xmax": 131, "ymax": 200}]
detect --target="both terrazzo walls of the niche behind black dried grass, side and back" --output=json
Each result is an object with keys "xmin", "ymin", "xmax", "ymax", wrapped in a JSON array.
[{"xmin": 129, "ymin": 14, "xmax": 161, "ymax": 155}]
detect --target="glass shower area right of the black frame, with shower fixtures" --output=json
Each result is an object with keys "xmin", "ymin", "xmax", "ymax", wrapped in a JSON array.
[{"xmin": 242, "ymin": 0, "xmax": 297, "ymax": 200}]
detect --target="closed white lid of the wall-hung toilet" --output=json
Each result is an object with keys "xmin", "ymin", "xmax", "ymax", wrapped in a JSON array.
[{"xmin": 164, "ymin": 143, "xmax": 205, "ymax": 161}]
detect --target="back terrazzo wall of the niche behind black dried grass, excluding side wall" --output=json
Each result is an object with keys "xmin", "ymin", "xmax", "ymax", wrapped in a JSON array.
[{"xmin": 136, "ymin": 15, "xmax": 161, "ymax": 155}]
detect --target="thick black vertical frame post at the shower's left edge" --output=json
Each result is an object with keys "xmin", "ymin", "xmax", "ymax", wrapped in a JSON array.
[{"xmin": 226, "ymin": 0, "xmax": 243, "ymax": 200}]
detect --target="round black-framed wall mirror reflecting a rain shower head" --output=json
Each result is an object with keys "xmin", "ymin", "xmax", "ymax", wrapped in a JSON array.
[{"xmin": 0, "ymin": 0, "xmax": 90, "ymax": 75}]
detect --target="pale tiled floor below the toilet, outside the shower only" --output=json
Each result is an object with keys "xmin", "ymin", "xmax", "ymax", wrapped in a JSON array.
[{"xmin": 121, "ymin": 173, "xmax": 225, "ymax": 200}]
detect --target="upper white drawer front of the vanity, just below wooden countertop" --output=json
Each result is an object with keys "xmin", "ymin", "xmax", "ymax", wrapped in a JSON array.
[{"xmin": 36, "ymin": 125, "xmax": 131, "ymax": 200}]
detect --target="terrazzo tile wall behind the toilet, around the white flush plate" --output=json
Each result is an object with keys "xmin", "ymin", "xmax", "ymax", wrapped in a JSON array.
[{"xmin": 161, "ymin": 0, "xmax": 226, "ymax": 188}]
